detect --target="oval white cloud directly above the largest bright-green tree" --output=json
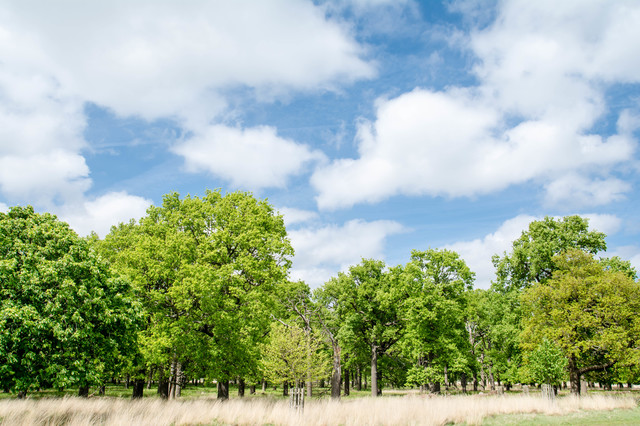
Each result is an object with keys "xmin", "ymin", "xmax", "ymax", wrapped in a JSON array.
[{"xmin": 173, "ymin": 125, "xmax": 324, "ymax": 189}]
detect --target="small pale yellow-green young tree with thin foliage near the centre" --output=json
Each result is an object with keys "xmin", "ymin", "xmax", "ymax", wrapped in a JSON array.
[{"xmin": 262, "ymin": 322, "xmax": 331, "ymax": 387}]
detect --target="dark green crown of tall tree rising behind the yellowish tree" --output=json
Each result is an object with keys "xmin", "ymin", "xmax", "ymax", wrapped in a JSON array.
[{"xmin": 493, "ymin": 216, "xmax": 607, "ymax": 290}]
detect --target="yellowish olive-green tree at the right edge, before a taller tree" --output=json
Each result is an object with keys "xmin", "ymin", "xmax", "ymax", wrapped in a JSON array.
[{"xmin": 522, "ymin": 249, "xmax": 640, "ymax": 394}]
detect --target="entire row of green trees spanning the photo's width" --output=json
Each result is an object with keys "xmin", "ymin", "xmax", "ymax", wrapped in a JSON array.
[{"xmin": 0, "ymin": 190, "xmax": 640, "ymax": 399}]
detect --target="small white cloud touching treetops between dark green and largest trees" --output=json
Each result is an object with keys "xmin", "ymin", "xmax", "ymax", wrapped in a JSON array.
[{"xmin": 59, "ymin": 192, "xmax": 152, "ymax": 238}]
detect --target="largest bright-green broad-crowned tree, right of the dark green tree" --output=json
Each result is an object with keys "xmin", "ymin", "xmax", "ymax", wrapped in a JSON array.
[{"xmin": 100, "ymin": 191, "xmax": 293, "ymax": 399}]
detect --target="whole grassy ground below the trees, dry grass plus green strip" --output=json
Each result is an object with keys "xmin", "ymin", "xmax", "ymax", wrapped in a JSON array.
[{"xmin": 0, "ymin": 386, "xmax": 640, "ymax": 426}]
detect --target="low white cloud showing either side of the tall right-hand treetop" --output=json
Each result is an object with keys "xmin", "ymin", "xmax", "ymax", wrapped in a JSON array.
[{"xmin": 445, "ymin": 213, "xmax": 622, "ymax": 288}]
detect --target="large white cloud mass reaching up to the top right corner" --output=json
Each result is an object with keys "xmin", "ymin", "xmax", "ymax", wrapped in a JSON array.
[{"xmin": 312, "ymin": 1, "xmax": 640, "ymax": 209}]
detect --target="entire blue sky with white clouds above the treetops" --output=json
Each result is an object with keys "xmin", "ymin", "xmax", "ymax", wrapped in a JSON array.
[{"xmin": 0, "ymin": 0, "xmax": 640, "ymax": 288}]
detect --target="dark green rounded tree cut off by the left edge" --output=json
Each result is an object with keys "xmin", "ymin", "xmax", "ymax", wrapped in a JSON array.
[{"xmin": 0, "ymin": 207, "xmax": 140, "ymax": 397}]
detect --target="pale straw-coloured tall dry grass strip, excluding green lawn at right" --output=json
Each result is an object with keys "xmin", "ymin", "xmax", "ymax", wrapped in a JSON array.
[{"xmin": 0, "ymin": 395, "xmax": 636, "ymax": 426}]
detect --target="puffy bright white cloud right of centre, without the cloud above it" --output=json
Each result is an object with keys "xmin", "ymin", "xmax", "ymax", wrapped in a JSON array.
[{"xmin": 311, "ymin": 89, "xmax": 635, "ymax": 209}]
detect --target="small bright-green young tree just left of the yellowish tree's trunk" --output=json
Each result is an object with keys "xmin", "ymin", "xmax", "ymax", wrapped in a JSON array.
[{"xmin": 527, "ymin": 339, "xmax": 567, "ymax": 385}]
